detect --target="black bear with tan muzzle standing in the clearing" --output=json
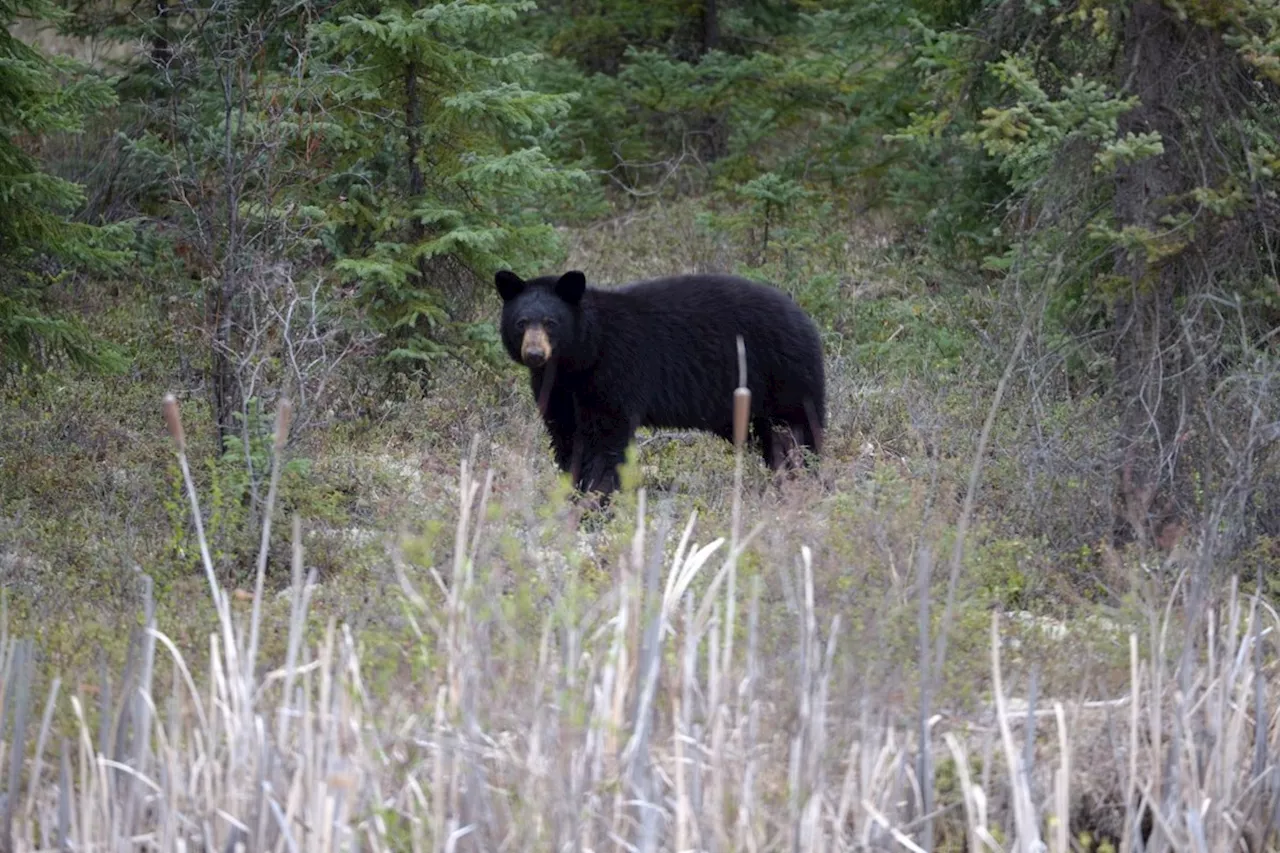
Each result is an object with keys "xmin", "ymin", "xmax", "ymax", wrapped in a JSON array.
[{"xmin": 494, "ymin": 270, "xmax": 826, "ymax": 500}]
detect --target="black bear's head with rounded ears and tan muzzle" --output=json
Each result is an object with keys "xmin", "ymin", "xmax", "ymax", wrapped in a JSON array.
[{"xmin": 494, "ymin": 270, "xmax": 586, "ymax": 369}]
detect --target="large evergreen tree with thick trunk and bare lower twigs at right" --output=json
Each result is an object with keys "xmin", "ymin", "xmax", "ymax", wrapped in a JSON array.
[{"xmin": 897, "ymin": 0, "xmax": 1280, "ymax": 542}]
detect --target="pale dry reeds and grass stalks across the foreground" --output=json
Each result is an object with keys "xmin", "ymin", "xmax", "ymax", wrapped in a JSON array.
[{"xmin": 0, "ymin": 389, "xmax": 1280, "ymax": 852}]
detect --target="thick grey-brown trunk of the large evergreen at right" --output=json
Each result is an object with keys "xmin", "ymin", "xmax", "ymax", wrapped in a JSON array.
[{"xmin": 1114, "ymin": 0, "xmax": 1198, "ymax": 546}]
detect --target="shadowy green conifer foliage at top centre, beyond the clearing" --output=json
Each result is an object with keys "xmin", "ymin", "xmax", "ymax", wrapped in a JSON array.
[{"xmin": 532, "ymin": 0, "xmax": 908, "ymax": 199}]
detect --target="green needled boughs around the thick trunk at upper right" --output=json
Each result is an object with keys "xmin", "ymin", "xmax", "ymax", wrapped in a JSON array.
[{"xmin": 891, "ymin": 0, "xmax": 1280, "ymax": 285}]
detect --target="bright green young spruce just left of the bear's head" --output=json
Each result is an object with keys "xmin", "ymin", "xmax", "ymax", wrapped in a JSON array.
[{"xmin": 314, "ymin": 0, "xmax": 581, "ymax": 368}]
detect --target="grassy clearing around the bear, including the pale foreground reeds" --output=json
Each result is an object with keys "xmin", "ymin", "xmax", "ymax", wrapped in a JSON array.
[{"xmin": 0, "ymin": 206, "xmax": 1280, "ymax": 850}]
